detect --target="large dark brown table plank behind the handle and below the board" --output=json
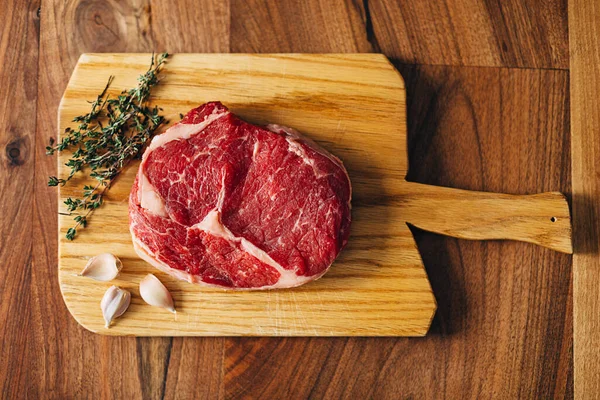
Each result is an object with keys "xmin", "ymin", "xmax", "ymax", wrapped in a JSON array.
[{"xmin": 224, "ymin": 66, "xmax": 573, "ymax": 399}]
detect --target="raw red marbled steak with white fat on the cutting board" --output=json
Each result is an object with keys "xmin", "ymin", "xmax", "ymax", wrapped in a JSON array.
[{"xmin": 129, "ymin": 102, "xmax": 351, "ymax": 289}]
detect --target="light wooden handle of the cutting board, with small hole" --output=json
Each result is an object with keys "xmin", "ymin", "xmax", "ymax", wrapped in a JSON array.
[{"xmin": 402, "ymin": 182, "xmax": 573, "ymax": 254}]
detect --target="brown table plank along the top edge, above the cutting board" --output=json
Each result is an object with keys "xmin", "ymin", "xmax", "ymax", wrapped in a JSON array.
[{"xmin": 231, "ymin": 0, "xmax": 569, "ymax": 69}]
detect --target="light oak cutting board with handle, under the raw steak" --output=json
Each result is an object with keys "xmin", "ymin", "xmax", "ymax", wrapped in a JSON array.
[{"xmin": 58, "ymin": 54, "xmax": 572, "ymax": 336}]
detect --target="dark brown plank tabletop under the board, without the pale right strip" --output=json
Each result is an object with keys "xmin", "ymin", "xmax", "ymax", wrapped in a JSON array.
[{"xmin": 0, "ymin": 0, "xmax": 598, "ymax": 399}]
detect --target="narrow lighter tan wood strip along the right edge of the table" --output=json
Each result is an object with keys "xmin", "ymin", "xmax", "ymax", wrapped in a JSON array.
[{"xmin": 569, "ymin": 0, "xmax": 600, "ymax": 399}]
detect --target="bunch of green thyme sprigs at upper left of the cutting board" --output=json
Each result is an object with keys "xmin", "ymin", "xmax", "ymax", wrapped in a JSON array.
[{"xmin": 46, "ymin": 53, "xmax": 169, "ymax": 240}]
